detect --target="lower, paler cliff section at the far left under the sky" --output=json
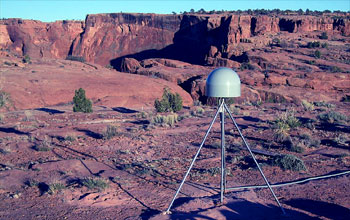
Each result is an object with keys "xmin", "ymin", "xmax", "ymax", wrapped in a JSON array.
[{"xmin": 0, "ymin": 19, "xmax": 84, "ymax": 58}]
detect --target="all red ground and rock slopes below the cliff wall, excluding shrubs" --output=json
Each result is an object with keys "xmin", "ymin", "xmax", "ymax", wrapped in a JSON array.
[{"xmin": 0, "ymin": 30, "xmax": 350, "ymax": 219}]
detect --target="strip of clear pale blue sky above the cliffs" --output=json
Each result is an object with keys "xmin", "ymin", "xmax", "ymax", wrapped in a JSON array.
[{"xmin": 0, "ymin": 0, "xmax": 350, "ymax": 21}]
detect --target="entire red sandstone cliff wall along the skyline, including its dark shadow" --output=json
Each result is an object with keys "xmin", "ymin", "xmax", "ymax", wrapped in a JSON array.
[{"xmin": 0, "ymin": 13, "xmax": 350, "ymax": 66}]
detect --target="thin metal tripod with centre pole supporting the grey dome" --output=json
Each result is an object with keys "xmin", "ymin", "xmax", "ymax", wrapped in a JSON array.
[{"xmin": 164, "ymin": 98, "xmax": 285, "ymax": 214}]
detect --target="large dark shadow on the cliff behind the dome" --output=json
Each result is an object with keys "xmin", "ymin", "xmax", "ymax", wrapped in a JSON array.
[{"xmin": 110, "ymin": 16, "xmax": 229, "ymax": 71}]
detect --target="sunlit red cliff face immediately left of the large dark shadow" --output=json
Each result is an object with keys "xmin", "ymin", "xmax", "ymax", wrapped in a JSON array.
[{"xmin": 71, "ymin": 13, "xmax": 181, "ymax": 65}]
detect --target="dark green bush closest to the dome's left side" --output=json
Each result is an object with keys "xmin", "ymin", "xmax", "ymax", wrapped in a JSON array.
[{"xmin": 154, "ymin": 88, "xmax": 182, "ymax": 112}]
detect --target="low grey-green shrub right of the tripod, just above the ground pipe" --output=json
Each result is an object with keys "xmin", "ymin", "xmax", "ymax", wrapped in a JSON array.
[{"xmin": 271, "ymin": 154, "xmax": 306, "ymax": 171}]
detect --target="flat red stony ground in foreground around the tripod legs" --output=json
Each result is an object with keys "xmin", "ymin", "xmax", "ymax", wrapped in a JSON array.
[{"xmin": 0, "ymin": 103, "xmax": 350, "ymax": 219}]
